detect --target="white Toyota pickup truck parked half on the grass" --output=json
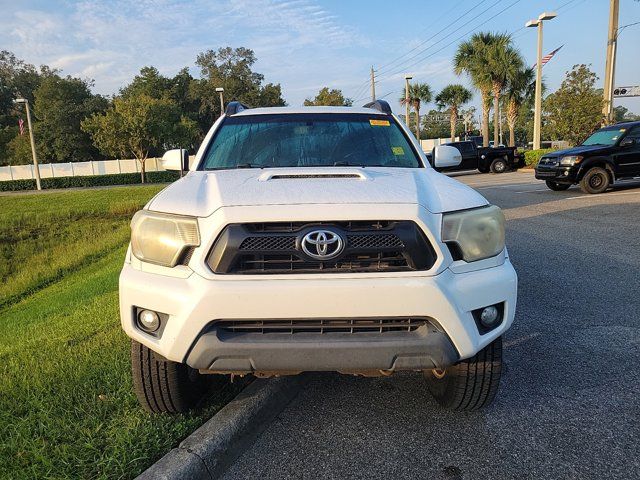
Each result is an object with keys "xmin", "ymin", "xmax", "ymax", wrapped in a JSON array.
[{"xmin": 120, "ymin": 101, "xmax": 517, "ymax": 412}]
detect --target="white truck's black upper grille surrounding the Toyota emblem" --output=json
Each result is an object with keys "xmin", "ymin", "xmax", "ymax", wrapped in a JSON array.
[{"xmin": 207, "ymin": 220, "xmax": 436, "ymax": 274}]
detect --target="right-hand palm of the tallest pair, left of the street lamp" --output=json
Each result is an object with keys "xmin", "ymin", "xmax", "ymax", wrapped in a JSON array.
[{"xmin": 485, "ymin": 34, "xmax": 524, "ymax": 145}]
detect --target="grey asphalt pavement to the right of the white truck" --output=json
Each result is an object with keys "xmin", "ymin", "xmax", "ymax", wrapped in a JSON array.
[{"xmin": 225, "ymin": 172, "xmax": 640, "ymax": 480}]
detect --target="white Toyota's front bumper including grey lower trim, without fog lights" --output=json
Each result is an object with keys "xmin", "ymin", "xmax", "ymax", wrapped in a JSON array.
[{"xmin": 120, "ymin": 258, "xmax": 517, "ymax": 372}]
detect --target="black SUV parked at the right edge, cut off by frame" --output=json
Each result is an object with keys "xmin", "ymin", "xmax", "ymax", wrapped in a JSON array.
[{"xmin": 536, "ymin": 122, "xmax": 640, "ymax": 193}]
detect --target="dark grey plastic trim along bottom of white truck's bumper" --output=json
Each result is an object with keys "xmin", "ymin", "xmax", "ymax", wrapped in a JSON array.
[{"xmin": 186, "ymin": 322, "xmax": 459, "ymax": 373}]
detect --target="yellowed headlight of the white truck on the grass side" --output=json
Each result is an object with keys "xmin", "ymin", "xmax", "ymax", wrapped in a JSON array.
[{"xmin": 131, "ymin": 210, "xmax": 200, "ymax": 267}]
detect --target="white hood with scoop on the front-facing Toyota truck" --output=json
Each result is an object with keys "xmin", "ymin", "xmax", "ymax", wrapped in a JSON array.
[{"xmin": 147, "ymin": 167, "xmax": 487, "ymax": 217}]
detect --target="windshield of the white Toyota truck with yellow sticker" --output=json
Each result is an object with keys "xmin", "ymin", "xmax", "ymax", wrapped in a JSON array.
[{"xmin": 200, "ymin": 113, "xmax": 421, "ymax": 170}]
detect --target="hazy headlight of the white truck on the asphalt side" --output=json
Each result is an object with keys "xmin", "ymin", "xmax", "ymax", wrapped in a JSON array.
[{"xmin": 442, "ymin": 205, "xmax": 504, "ymax": 262}]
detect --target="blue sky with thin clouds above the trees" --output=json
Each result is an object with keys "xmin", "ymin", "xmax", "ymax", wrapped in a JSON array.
[{"xmin": 0, "ymin": 0, "xmax": 640, "ymax": 113}]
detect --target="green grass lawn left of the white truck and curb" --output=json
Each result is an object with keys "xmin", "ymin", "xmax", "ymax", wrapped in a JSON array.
[{"xmin": 0, "ymin": 187, "xmax": 241, "ymax": 479}]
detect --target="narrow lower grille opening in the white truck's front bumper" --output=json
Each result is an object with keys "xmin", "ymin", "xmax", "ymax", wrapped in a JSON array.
[{"xmin": 214, "ymin": 317, "xmax": 428, "ymax": 334}]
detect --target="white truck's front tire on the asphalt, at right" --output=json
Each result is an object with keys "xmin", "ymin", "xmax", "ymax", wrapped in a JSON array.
[{"xmin": 424, "ymin": 337, "xmax": 502, "ymax": 411}]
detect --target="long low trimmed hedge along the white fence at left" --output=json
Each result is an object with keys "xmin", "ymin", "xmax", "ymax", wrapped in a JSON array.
[{"xmin": 0, "ymin": 171, "xmax": 180, "ymax": 192}]
